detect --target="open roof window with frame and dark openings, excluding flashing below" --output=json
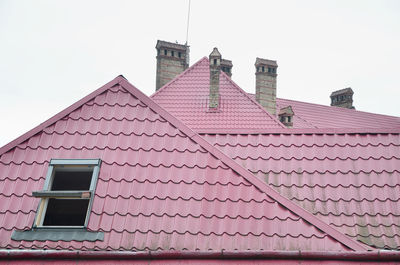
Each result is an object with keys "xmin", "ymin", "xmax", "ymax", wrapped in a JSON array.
[{"xmin": 33, "ymin": 159, "xmax": 100, "ymax": 228}]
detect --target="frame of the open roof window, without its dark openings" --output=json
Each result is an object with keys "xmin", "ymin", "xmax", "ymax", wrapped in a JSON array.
[{"xmin": 32, "ymin": 159, "xmax": 101, "ymax": 229}]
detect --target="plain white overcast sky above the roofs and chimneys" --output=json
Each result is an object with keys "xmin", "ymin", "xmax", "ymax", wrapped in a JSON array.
[{"xmin": 0, "ymin": 0, "xmax": 400, "ymax": 146}]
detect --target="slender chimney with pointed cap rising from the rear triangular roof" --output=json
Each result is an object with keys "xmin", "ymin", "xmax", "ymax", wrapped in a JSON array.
[{"xmin": 208, "ymin": 48, "xmax": 221, "ymax": 110}]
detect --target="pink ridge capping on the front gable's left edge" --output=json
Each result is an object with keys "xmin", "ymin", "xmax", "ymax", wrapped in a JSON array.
[{"xmin": 0, "ymin": 75, "xmax": 126, "ymax": 155}]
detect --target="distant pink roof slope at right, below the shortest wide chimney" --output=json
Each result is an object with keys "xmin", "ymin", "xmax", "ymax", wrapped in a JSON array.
[{"xmin": 276, "ymin": 96, "xmax": 400, "ymax": 128}]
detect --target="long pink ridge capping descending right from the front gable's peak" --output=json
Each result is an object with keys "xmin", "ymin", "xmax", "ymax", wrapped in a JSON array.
[{"xmin": 115, "ymin": 78, "xmax": 369, "ymax": 251}]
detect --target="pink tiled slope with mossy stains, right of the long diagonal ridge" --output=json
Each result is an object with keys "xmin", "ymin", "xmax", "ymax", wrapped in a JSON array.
[{"xmin": 205, "ymin": 130, "xmax": 400, "ymax": 250}]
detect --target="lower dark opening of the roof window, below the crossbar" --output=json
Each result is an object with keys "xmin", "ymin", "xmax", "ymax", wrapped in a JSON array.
[{"xmin": 43, "ymin": 198, "xmax": 89, "ymax": 226}]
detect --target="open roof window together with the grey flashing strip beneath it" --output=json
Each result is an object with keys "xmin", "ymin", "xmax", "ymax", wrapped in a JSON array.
[{"xmin": 11, "ymin": 159, "xmax": 104, "ymax": 241}]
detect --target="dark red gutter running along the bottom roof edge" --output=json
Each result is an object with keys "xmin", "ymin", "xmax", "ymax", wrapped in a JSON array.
[{"xmin": 0, "ymin": 250, "xmax": 400, "ymax": 261}]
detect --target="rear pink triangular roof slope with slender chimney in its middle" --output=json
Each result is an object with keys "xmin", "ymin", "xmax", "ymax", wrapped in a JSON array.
[{"xmin": 151, "ymin": 57, "xmax": 283, "ymax": 132}]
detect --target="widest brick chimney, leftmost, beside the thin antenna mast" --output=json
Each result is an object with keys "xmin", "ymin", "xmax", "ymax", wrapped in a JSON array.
[{"xmin": 156, "ymin": 40, "xmax": 189, "ymax": 90}]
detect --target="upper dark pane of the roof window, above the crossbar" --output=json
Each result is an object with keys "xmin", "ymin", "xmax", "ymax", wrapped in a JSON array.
[{"xmin": 51, "ymin": 170, "xmax": 93, "ymax": 190}]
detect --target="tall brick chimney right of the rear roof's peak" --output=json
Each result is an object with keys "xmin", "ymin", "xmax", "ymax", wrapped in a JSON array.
[{"xmin": 254, "ymin": 58, "xmax": 278, "ymax": 116}]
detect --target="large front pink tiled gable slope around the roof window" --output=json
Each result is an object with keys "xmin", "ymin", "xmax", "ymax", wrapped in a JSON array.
[{"xmin": 0, "ymin": 77, "xmax": 366, "ymax": 251}]
